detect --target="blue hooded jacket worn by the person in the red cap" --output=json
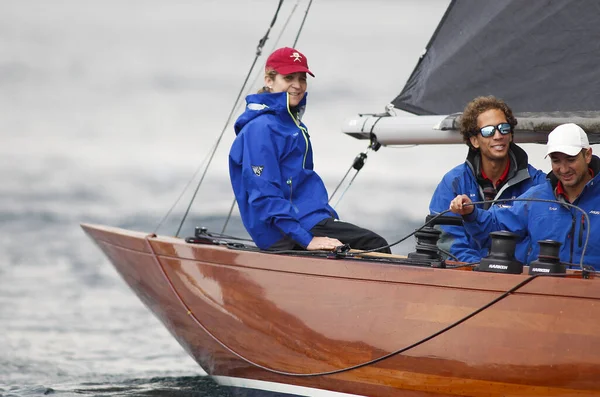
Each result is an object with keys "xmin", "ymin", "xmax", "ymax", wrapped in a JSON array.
[{"xmin": 229, "ymin": 92, "xmax": 338, "ymax": 249}]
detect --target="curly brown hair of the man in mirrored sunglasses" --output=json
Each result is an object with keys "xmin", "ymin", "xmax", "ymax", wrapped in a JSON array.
[{"xmin": 460, "ymin": 95, "xmax": 517, "ymax": 149}]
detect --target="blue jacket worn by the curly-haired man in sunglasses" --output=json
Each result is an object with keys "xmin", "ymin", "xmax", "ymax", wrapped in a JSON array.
[{"xmin": 429, "ymin": 143, "xmax": 546, "ymax": 263}]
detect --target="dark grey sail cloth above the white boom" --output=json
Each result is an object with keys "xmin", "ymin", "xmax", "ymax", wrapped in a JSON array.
[{"xmin": 392, "ymin": 0, "xmax": 600, "ymax": 115}]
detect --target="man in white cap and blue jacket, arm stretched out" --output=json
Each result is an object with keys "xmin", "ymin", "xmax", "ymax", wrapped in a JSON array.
[{"xmin": 450, "ymin": 123, "xmax": 600, "ymax": 270}]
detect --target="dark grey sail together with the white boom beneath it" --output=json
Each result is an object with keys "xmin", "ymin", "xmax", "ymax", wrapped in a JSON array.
[{"xmin": 342, "ymin": 0, "xmax": 600, "ymax": 145}]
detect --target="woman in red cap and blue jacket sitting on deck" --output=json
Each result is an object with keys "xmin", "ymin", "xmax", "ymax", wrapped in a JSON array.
[{"xmin": 229, "ymin": 47, "xmax": 391, "ymax": 253}]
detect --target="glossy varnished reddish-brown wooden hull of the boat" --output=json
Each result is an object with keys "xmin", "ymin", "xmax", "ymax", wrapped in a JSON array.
[{"xmin": 83, "ymin": 225, "xmax": 600, "ymax": 396}]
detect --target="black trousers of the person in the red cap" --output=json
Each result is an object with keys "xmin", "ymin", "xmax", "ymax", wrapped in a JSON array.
[{"xmin": 269, "ymin": 218, "xmax": 392, "ymax": 254}]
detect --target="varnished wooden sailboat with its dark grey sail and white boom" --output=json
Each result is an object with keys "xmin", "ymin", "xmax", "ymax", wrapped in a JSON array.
[{"xmin": 82, "ymin": 0, "xmax": 600, "ymax": 396}]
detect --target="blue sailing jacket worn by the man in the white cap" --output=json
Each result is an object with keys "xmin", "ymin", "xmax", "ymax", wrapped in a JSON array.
[{"xmin": 463, "ymin": 156, "xmax": 600, "ymax": 270}]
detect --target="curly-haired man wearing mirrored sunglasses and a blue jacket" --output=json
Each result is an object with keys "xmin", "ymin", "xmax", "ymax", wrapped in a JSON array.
[{"xmin": 429, "ymin": 96, "xmax": 546, "ymax": 263}]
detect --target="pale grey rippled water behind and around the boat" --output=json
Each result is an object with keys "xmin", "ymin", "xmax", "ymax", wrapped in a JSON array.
[{"xmin": 0, "ymin": 0, "xmax": 552, "ymax": 397}]
